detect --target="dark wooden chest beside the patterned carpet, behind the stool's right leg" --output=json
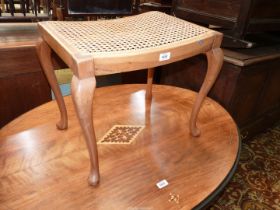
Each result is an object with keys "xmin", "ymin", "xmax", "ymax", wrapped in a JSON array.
[{"xmin": 160, "ymin": 45, "xmax": 280, "ymax": 138}]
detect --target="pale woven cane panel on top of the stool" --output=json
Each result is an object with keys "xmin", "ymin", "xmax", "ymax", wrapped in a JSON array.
[{"xmin": 42, "ymin": 12, "xmax": 209, "ymax": 55}]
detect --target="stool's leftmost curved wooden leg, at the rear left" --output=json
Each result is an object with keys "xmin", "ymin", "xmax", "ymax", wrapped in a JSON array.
[{"xmin": 36, "ymin": 41, "xmax": 68, "ymax": 130}]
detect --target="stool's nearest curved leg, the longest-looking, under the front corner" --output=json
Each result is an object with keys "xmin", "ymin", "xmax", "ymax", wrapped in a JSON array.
[{"xmin": 71, "ymin": 76, "xmax": 100, "ymax": 186}]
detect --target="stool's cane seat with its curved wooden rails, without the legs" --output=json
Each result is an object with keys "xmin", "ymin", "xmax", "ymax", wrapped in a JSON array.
[{"xmin": 39, "ymin": 12, "xmax": 220, "ymax": 75}]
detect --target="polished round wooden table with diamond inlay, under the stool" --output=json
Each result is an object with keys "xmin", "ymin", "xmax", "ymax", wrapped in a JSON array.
[{"xmin": 0, "ymin": 85, "xmax": 240, "ymax": 210}]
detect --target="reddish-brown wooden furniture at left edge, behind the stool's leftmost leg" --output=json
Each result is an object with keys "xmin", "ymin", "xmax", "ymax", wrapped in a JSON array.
[{"xmin": 0, "ymin": 23, "xmax": 51, "ymax": 127}]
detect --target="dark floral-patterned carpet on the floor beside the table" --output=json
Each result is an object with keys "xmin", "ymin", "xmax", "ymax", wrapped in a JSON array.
[{"xmin": 209, "ymin": 124, "xmax": 280, "ymax": 210}]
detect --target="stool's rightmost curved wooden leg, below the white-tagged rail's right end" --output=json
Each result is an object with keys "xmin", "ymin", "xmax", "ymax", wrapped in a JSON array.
[{"xmin": 190, "ymin": 48, "xmax": 224, "ymax": 136}]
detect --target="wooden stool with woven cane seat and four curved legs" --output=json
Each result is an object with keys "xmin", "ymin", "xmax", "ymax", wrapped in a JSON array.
[{"xmin": 37, "ymin": 12, "xmax": 223, "ymax": 185}]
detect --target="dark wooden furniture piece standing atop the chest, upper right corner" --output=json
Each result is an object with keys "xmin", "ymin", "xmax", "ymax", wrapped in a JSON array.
[{"xmin": 173, "ymin": 0, "xmax": 280, "ymax": 48}]
